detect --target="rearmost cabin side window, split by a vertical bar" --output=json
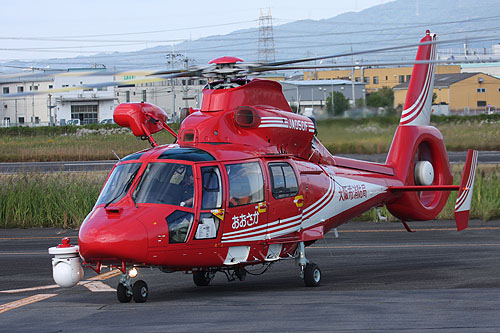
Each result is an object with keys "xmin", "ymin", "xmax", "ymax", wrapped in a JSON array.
[{"xmin": 269, "ymin": 163, "xmax": 299, "ymax": 199}]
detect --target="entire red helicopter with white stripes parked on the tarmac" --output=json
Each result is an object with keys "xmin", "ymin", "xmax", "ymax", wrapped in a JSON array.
[{"xmin": 49, "ymin": 31, "xmax": 477, "ymax": 302}]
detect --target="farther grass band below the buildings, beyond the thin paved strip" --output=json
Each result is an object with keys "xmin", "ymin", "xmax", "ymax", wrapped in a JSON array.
[{"xmin": 0, "ymin": 115, "xmax": 500, "ymax": 162}]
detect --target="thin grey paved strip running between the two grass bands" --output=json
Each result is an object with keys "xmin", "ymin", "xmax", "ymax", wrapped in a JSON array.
[{"xmin": 0, "ymin": 151, "xmax": 500, "ymax": 173}]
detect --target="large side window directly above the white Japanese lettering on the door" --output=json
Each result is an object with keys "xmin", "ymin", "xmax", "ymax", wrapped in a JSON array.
[{"xmin": 226, "ymin": 162, "xmax": 264, "ymax": 207}]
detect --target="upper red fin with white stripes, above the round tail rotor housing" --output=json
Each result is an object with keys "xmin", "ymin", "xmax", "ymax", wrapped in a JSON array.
[{"xmin": 399, "ymin": 30, "xmax": 436, "ymax": 125}]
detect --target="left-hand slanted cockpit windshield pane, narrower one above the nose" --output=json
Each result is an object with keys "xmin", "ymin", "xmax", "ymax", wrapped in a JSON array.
[{"xmin": 96, "ymin": 163, "xmax": 141, "ymax": 205}]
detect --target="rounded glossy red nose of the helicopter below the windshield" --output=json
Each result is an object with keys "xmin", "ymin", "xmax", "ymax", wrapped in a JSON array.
[{"xmin": 78, "ymin": 208, "xmax": 147, "ymax": 262}]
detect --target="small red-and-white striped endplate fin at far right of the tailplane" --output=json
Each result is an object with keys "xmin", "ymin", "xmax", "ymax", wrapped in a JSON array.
[{"xmin": 455, "ymin": 149, "xmax": 478, "ymax": 231}]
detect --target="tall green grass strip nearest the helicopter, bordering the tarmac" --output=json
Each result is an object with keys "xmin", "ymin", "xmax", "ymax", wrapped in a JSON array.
[{"xmin": 0, "ymin": 165, "xmax": 500, "ymax": 228}]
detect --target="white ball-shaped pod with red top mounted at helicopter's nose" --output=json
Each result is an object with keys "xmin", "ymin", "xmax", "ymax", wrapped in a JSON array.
[{"xmin": 49, "ymin": 237, "xmax": 83, "ymax": 288}]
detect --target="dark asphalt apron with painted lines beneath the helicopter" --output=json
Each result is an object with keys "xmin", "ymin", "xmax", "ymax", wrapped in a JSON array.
[{"xmin": 0, "ymin": 221, "xmax": 500, "ymax": 332}]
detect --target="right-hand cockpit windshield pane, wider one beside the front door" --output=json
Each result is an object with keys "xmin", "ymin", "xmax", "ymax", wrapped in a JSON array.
[{"xmin": 132, "ymin": 163, "xmax": 194, "ymax": 207}]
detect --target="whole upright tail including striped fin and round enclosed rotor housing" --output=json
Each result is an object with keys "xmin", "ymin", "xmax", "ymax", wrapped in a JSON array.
[{"xmin": 386, "ymin": 31, "xmax": 453, "ymax": 221}]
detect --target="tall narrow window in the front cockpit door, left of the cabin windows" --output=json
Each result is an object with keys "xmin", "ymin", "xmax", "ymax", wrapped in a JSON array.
[{"xmin": 201, "ymin": 166, "xmax": 222, "ymax": 209}]
